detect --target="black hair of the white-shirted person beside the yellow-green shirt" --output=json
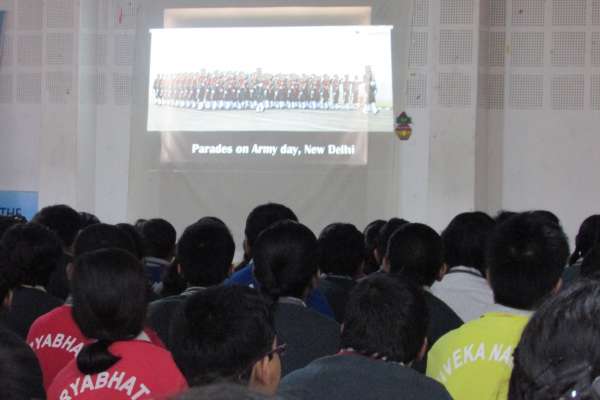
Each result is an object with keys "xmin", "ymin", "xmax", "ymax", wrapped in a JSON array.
[{"xmin": 441, "ymin": 211, "xmax": 496, "ymax": 275}]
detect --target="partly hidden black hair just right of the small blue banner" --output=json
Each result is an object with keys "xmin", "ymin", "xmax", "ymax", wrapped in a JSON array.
[{"xmin": 32, "ymin": 204, "xmax": 81, "ymax": 248}]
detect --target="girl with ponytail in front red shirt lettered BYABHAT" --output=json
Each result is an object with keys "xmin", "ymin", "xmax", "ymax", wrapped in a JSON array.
[{"xmin": 48, "ymin": 249, "xmax": 187, "ymax": 400}]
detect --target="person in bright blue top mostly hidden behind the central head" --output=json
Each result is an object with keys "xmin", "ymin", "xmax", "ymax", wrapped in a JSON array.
[{"xmin": 228, "ymin": 203, "xmax": 334, "ymax": 318}]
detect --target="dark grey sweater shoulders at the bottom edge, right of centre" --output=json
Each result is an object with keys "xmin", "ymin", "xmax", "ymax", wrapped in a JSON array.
[{"xmin": 279, "ymin": 355, "xmax": 451, "ymax": 400}]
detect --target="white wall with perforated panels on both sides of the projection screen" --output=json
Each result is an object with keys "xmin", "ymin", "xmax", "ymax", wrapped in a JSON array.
[{"xmin": 0, "ymin": 0, "xmax": 600, "ymax": 245}]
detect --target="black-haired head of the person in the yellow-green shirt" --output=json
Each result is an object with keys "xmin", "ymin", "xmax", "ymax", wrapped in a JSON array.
[{"xmin": 486, "ymin": 212, "xmax": 569, "ymax": 310}]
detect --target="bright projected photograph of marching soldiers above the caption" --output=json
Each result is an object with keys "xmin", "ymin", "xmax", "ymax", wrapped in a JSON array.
[{"xmin": 148, "ymin": 26, "xmax": 394, "ymax": 132}]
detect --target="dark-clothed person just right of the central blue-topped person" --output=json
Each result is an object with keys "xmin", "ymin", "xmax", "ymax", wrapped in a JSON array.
[{"xmin": 317, "ymin": 223, "xmax": 365, "ymax": 323}]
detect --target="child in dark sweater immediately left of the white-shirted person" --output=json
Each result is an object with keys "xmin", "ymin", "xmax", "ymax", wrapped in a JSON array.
[{"xmin": 384, "ymin": 224, "xmax": 462, "ymax": 352}]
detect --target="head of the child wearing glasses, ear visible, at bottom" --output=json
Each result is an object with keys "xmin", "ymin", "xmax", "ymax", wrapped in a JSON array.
[{"xmin": 170, "ymin": 285, "xmax": 281, "ymax": 394}]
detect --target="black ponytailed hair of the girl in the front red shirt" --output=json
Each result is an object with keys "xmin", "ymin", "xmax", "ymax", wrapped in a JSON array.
[{"xmin": 72, "ymin": 249, "xmax": 147, "ymax": 374}]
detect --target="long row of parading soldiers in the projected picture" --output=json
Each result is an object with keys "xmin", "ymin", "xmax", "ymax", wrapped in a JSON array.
[{"xmin": 153, "ymin": 67, "xmax": 379, "ymax": 114}]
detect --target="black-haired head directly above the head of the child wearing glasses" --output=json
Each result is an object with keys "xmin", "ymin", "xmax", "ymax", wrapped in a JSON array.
[{"xmin": 177, "ymin": 218, "xmax": 235, "ymax": 287}]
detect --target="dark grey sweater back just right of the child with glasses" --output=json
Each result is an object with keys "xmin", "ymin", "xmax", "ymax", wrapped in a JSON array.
[{"xmin": 275, "ymin": 302, "xmax": 340, "ymax": 376}]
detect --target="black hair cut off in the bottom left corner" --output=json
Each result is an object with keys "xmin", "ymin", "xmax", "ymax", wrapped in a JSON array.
[{"xmin": 0, "ymin": 329, "xmax": 46, "ymax": 400}]
